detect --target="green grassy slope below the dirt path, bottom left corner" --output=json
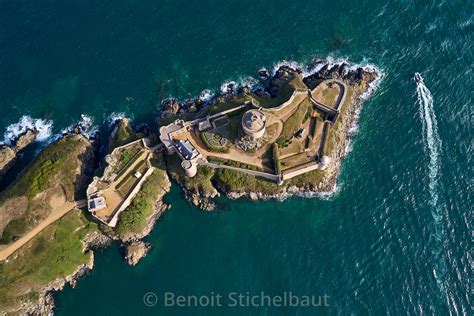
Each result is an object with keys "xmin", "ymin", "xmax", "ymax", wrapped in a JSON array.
[{"xmin": 0, "ymin": 210, "xmax": 97, "ymax": 311}]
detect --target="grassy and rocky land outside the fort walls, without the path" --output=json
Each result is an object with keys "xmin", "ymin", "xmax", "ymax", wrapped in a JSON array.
[{"xmin": 0, "ymin": 61, "xmax": 381, "ymax": 314}]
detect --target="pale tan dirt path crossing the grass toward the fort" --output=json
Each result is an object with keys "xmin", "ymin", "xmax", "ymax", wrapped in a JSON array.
[{"xmin": 0, "ymin": 202, "xmax": 76, "ymax": 261}]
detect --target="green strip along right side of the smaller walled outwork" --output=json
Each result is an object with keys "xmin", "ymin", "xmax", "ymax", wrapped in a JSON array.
[{"xmin": 115, "ymin": 154, "xmax": 168, "ymax": 237}]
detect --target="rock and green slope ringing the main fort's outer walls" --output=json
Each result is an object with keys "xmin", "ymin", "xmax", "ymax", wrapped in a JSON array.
[{"xmin": 159, "ymin": 59, "xmax": 381, "ymax": 210}]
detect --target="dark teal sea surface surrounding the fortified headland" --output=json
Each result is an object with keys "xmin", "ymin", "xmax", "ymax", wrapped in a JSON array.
[{"xmin": 0, "ymin": 0, "xmax": 474, "ymax": 315}]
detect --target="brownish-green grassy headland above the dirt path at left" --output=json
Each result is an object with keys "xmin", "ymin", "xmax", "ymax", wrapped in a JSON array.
[{"xmin": 0, "ymin": 135, "xmax": 92, "ymax": 244}]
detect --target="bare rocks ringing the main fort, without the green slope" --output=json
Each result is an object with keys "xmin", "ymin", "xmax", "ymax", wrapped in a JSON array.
[{"xmin": 160, "ymin": 59, "xmax": 382, "ymax": 207}]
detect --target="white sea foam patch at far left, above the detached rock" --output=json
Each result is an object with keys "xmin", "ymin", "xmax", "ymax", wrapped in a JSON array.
[{"xmin": 2, "ymin": 115, "xmax": 53, "ymax": 144}]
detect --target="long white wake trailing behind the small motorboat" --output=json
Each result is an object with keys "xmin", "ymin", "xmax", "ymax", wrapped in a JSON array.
[{"xmin": 415, "ymin": 73, "xmax": 446, "ymax": 292}]
